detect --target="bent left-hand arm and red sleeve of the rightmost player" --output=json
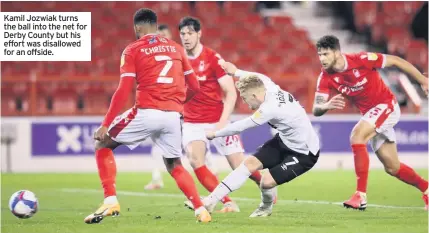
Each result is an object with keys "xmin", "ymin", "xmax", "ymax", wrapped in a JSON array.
[{"xmin": 313, "ymin": 73, "xmax": 345, "ymax": 116}]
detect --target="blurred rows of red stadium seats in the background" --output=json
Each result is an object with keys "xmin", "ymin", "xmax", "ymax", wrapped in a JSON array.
[{"xmin": 1, "ymin": 1, "xmax": 422, "ymax": 115}]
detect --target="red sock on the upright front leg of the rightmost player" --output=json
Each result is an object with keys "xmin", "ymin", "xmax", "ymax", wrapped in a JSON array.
[{"xmin": 352, "ymin": 144, "xmax": 369, "ymax": 193}]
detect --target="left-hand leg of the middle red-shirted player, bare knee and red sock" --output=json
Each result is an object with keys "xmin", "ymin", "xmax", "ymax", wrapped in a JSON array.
[{"xmin": 185, "ymin": 141, "xmax": 233, "ymax": 208}]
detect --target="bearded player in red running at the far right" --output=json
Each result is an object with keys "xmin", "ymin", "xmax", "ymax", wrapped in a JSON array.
[{"xmin": 313, "ymin": 36, "xmax": 428, "ymax": 210}]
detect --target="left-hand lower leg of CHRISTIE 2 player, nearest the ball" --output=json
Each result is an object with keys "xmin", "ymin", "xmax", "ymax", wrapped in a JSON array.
[{"xmin": 84, "ymin": 138, "xmax": 121, "ymax": 224}]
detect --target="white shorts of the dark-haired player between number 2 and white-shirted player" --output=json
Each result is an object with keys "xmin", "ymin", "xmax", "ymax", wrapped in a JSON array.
[{"xmin": 183, "ymin": 122, "xmax": 244, "ymax": 155}]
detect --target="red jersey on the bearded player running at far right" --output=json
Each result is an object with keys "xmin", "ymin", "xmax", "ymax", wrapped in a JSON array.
[{"xmin": 317, "ymin": 52, "xmax": 395, "ymax": 115}]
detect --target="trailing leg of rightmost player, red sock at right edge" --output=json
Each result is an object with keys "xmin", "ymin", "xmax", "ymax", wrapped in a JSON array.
[{"xmin": 375, "ymin": 141, "xmax": 428, "ymax": 210}]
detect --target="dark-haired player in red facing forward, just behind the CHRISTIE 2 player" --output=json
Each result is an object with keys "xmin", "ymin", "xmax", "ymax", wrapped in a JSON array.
[{"xmin": 179, "ymin": 17, "xmax": 261, "ymax": 212}]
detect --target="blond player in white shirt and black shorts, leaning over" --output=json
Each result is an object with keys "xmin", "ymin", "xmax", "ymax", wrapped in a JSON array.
[{"xmin": 203, "ymin": 61, "xmax": 320, "ymax": 217}]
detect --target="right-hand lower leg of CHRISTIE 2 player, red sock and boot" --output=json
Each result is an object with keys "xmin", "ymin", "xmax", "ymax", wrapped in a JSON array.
[{"xmin": 164, "ymin": 158, "xmax": 211, "ymax": 222}]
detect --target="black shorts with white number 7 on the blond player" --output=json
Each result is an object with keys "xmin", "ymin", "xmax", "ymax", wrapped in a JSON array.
[{"xmin": 254, "ymin": 134, "xmax": 319, "ymax": 185}]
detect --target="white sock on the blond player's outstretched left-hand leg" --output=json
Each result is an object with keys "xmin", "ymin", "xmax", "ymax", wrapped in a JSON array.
[{"xmin": 207, "ymin": 163, "xmax": 251, "ymax": 204}]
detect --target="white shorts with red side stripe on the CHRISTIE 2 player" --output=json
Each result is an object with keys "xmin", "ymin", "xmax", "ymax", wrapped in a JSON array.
[{"xmin": 109, "ymin": 108, "xmax": 182, "ymax": 158}]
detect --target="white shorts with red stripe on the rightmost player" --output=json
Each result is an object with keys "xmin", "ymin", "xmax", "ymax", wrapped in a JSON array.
[{"xmin": 362, "ymin": 102, "xmax": 401, "ymax": 152}]
